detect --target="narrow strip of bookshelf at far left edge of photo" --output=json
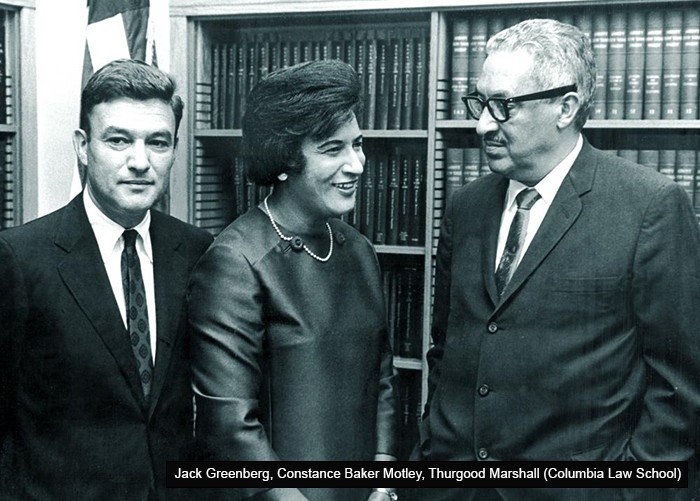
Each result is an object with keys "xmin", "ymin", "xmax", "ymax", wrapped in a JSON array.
[{"xmin": 0, "ymin": 0, "xmax": 37, "ymax": 229}]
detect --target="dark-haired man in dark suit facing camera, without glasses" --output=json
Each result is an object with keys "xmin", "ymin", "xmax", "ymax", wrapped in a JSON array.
[{"xmin": 0, "ymin": 60, "xmax": 211, "ymax": 501}]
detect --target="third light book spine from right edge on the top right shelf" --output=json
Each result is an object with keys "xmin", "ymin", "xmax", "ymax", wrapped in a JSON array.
[{"xmin": 643, "ymin": 11, "xmax": 664, "ymax": 120}]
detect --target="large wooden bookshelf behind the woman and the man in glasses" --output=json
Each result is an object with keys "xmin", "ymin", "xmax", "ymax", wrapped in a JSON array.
[{"xmin": 171, "ymin": 0, "xmax": 700, "ymax": 455}]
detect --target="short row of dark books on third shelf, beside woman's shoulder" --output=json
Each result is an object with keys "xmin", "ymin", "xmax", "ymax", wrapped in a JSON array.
[{"xmin": 382, "ymin": 267, "xmax": 423, "ymax": 358}]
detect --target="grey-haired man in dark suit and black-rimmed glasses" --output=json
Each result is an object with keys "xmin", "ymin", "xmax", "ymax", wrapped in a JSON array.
[{"xmin": 416, "ymin": 20, "xmax": 700, "ymax": 500}]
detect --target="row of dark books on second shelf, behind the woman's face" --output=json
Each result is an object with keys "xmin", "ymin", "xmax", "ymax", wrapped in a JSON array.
[{"xmin": 194, "ymin": 145, "xmax": 426, "ymax": 246}]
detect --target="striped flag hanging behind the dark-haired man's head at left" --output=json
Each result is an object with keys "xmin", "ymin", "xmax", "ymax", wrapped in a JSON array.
[{"xmin": 70, "ymin": 0, "xmax": 170, "ymax": 198}]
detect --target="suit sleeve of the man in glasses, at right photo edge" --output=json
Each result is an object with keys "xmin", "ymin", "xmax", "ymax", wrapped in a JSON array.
[{"xmin": 628, "ymin": 184, "xmax": 700, "ymax": 460}]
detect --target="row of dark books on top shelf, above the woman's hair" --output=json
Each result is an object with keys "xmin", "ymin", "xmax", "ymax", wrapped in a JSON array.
[{"xmin": 202, "ymin": 25, "xmax": 429, "ymax": 129}]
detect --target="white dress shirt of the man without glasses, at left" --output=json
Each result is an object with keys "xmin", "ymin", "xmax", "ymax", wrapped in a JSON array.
[{"xmin": 83, "ymin": 186, "xmax": 157, "ymax": 364}]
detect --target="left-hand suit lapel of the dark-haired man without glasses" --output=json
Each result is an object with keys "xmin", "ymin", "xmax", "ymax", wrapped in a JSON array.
[{"xmin": 54, "ymin": 195, "xmax": 145, "ymax": 407}]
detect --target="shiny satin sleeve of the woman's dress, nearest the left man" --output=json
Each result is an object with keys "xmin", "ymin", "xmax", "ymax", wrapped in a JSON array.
[{"xmin": 188, "ymin": 242, "xmax": 301, "ymax": 501}]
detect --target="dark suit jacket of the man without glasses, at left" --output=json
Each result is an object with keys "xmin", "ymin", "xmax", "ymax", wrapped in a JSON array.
[{"xmin": 0, "ymin": 196, "xmax": 211, "ymax": 501}]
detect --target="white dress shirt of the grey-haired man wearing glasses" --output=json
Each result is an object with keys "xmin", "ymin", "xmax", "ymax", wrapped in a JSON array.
[{"xmin": 493, "ymin": 134, "xmax": 583, "ymax": 272}]
